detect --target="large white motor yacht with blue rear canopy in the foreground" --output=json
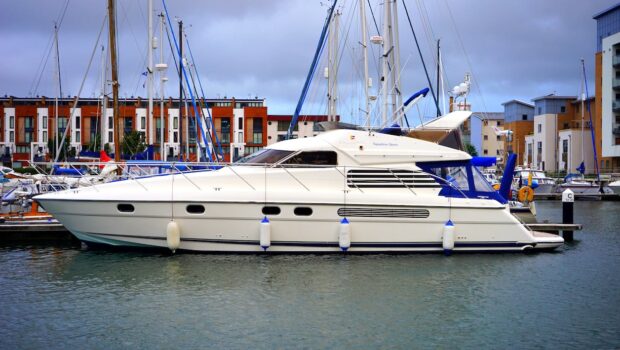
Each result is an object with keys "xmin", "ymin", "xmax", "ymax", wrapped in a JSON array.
[{"xmin": 35, "ymin": 126, "xmax": 564, "ymax": 253}]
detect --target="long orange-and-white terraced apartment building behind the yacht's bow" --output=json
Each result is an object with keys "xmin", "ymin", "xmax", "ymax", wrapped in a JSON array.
[{"xmin": 0, "ymin": 96, "xmax": 267, "ymax": 166}]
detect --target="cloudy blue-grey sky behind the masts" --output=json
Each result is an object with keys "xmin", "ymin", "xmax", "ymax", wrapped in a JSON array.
[{"xmin": 0, "ymin": 0, "xmax": 615, "ymax": 122}]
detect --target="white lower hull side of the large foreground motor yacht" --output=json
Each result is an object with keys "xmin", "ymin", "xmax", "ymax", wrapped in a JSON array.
[{"xmin": 38, "ymin": 199, "xmax": 563, "ymax": 253}]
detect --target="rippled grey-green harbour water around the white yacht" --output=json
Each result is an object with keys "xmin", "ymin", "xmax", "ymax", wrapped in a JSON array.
[{"xmin": 0, "ymin": 202, "xmax": 620, "ymax": 349}]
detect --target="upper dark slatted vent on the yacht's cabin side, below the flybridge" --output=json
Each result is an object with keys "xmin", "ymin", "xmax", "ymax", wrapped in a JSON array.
[{"xmin": 347, "ymin": 169, "xmax": 441, "ymax": 188}]
